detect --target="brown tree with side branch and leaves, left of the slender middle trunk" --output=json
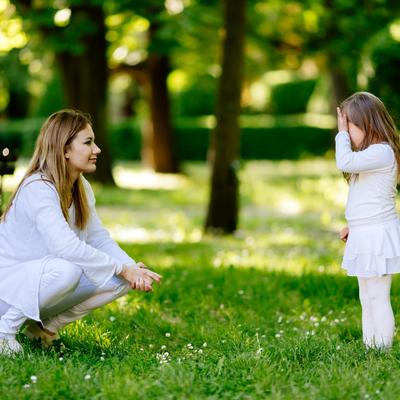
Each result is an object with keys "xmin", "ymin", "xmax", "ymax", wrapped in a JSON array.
[{"xmin": 108, "ymin": 0, "xmax": 179, "ymax": 173}]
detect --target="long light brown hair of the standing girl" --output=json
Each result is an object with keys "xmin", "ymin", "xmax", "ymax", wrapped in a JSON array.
[{"xmin": 340, "ymin": 92, "xmax": 400, "ymax": 181}]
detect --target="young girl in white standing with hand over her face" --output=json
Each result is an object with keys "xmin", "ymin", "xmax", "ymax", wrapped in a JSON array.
[{"xmin": 336, "ymin": 92, "xmax": 400, "ymax": 349}]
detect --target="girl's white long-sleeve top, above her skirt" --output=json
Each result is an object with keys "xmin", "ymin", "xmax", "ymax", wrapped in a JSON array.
[{"xmin": 335, "ymin": 131, "xmax": 397, "ymax": 226}]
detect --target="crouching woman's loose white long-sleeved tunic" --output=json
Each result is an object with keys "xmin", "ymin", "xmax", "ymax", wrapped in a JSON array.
[{"xmin": 0, "ymin": 174, "xmax": 134, "ymax": 320}]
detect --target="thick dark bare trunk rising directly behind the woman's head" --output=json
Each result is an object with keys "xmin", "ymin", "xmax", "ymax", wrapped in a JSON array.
[{"xmin": 57, "ymin": 5, "xmax": 114, "ymax": 184}]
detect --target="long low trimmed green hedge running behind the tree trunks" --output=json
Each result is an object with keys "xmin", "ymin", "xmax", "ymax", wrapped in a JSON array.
[{"xmin": 0, "ymin": 116, "xmax": 333, "ymax": 161}]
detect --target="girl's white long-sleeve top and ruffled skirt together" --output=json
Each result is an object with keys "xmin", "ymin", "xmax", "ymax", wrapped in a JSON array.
[{"xmin": 336, "ymin": 131, "xmax": 400, "ymax": 277}]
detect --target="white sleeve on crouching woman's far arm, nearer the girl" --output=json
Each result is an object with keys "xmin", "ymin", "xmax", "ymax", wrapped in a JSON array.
[{"xmin": 83, "ymin": 180, "xmax": 136, "ymax": 266}]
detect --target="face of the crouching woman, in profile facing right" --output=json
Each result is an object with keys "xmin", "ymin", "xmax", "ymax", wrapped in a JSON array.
[{"xmin": 65, "ymin": 125, "xmax": 101, "ymax": 177}]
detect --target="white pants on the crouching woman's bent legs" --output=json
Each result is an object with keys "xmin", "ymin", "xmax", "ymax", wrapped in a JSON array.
[{"xmin": 0, "ymin": 259, "xmax": 130, "ymax": 337}]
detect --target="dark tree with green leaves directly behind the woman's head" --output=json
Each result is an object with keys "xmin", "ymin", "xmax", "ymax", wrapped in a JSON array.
[{"xmin": 12, "ymin": 0, "xmax": 114, "ymax": 184}]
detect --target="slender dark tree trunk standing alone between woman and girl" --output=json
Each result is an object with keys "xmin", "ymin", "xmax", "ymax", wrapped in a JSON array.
[{"xmin": 205, "ymin": 0, "xmax": 246, "ymax": 233}]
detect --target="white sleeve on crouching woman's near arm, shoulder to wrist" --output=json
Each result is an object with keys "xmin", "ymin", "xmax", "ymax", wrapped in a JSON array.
[{"xmin": 19, "ymin": 180, "xmax": 123, "ymax": 286}]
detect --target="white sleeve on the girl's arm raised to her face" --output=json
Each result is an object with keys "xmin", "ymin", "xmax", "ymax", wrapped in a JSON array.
[{"xmin": 335, "ymin": 131, "xmax": 394, "ymax": 174}]
